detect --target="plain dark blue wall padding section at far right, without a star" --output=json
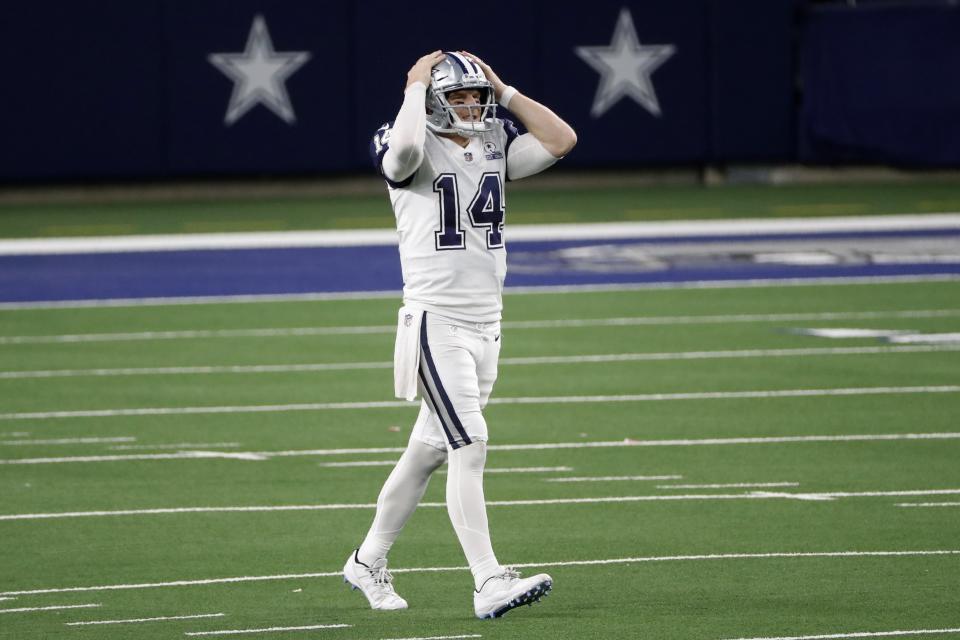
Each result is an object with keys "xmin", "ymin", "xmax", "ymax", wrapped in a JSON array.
[{"xmin": 800, "ymin": 2, "xmax": 960, "ymax": 166}]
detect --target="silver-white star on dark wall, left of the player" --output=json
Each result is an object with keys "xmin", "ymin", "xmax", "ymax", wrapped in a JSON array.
[{"xmin": 207, "ymin": 15, "xmax": 310, "ymax": 126}]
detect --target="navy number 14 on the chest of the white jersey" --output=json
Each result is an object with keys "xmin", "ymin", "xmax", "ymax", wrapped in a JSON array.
[{"xmin": 433, "ymin": 173, "xmax": 506, "ymax": 251}]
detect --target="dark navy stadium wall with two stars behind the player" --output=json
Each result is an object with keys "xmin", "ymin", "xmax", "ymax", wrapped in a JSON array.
[{"xmin": 0, "ymin": 0, "xmax": 960, "ymax": 182}]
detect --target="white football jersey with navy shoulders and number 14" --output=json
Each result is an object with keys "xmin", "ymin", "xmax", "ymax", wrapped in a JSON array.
[{"xmin": 371, "ymin": 120, "xmax": 517, "ymax": 322}]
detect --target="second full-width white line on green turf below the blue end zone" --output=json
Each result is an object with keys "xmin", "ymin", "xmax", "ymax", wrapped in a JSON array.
[{"xmin": 0, "ymin": 344, "xmax": 960, "ymax": 380}]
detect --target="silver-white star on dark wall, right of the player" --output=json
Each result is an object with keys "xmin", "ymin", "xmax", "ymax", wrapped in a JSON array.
[{"xmin": 574, "ymin": 8, "xmax": 677, "ymax": 118}]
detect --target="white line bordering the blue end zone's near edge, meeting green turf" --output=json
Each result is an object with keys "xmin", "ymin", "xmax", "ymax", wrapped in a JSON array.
[{"xmin": 0, "ymin": 273, "xmax": 960, "ymax": 311}]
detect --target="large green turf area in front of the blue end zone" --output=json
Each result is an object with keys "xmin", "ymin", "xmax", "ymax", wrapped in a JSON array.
[{"xmin": 0, "ymin": 282, "xmax": 960, "ymax": 640}]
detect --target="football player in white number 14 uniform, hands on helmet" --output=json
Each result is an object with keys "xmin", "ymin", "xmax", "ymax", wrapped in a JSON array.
[{"xmin": 343, "ymin": 51, "xmax": 577, "ymax": 618}]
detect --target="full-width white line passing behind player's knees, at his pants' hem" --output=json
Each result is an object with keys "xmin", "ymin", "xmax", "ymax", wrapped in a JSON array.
[{"xmin": 0, "ymin": 432, "xmax": 960, "ymax": 465}]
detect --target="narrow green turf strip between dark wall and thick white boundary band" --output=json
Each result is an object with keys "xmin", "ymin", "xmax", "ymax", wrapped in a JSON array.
[{"xmin": 0, "ymin": 179, "xmax": 960, "ymax": 238}]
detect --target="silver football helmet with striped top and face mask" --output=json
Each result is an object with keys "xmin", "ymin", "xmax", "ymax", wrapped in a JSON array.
[{"xmin": 427, "ymin": 51, "xmax": 497, "ymax": 136}]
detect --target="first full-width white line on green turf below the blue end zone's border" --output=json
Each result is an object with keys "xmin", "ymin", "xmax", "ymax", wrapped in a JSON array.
[{"xmin": 0, "ymin": 307, "xmax": 960, "ymax": 344}]
